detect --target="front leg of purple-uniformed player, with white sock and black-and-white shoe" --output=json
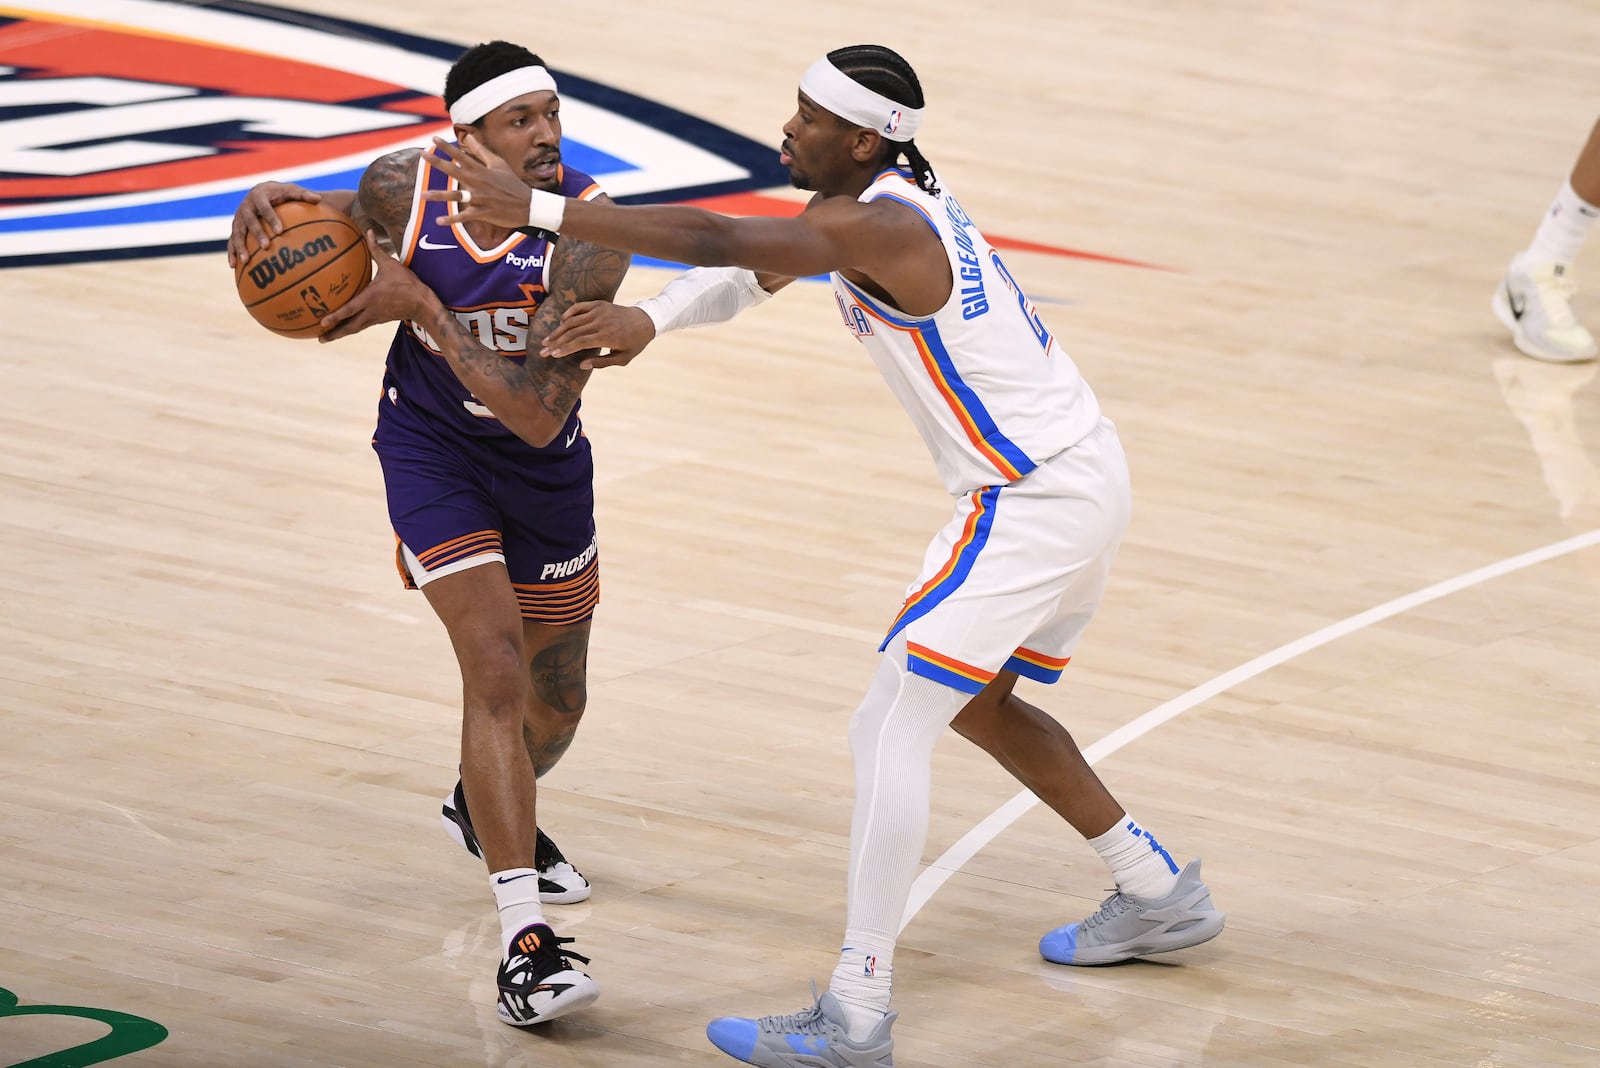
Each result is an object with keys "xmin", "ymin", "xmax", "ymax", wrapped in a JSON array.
[{"xmin": 422, "ymin": 561, "xmax": 600, "ymax": 1026}]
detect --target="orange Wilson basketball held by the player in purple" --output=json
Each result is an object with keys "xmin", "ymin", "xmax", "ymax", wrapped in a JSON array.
[{"xmin": 234, "ymin": 200, "xmax": 373, "ymax": 337}]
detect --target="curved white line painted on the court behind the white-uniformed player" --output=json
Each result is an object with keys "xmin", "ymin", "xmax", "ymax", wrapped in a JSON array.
[{"xmin": 899, "ymin": 529, "xmax": 1600, "ymax": 931}]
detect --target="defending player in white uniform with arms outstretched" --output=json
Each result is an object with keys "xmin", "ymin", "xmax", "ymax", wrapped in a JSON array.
[{"xmin": 427, "ymin": 46, "xmax": 1224, "ymax": 1068}]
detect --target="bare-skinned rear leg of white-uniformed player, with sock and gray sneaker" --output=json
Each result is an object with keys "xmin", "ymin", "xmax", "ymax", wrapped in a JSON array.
[{"xmin": 952, "ymin": 671, "xmax": 1226, "ymax": 964}]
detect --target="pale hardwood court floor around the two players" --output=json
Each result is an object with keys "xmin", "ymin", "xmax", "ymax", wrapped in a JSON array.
[{"xmin": 0, "ymin": 0, "xmax": 1600, "ymax": 1068}]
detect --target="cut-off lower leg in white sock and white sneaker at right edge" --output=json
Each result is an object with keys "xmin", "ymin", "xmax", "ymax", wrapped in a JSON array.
[{"xmin": 1491, "ymin": 115, "xmax": 1600, "ymax": 363}]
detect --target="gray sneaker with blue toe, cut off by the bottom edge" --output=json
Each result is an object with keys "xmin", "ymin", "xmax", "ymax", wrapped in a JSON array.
[{"xmin": 706, "ymin": 983, "xmax": 896, "ymax": 1068}]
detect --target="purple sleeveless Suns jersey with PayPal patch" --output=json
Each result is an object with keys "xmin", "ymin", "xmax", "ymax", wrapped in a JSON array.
[{"xmin": 384, "ymin": 149, "xmax": 600, "ymax": 459}]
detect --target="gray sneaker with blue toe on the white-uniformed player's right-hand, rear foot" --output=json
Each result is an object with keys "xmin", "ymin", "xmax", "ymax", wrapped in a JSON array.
[{"xmin": 1038, "ymin": 859, "xmax": 1227, "ymax": 964}]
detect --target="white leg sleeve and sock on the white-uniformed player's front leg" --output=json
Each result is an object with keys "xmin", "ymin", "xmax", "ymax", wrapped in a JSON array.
[{"xmin": 829, "ymin": 641, "xmax": 970, "ymax": 1039}]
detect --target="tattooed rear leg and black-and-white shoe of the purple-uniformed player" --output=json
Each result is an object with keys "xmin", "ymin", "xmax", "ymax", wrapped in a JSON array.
[{"xmin": 440, "ymin": 619, "xmax": 590, "ymax": 905}]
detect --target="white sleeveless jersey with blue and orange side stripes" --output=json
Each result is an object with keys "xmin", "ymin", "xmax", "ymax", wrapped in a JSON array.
[{"xmin": 832, "ymin": 169, "xmax": 1101, "ymax": 494}]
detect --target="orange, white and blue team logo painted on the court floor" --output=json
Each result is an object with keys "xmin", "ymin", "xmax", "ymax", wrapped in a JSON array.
[{"xmin": 0, "ymin": 0, "xmax": 789, "ymax": 267}]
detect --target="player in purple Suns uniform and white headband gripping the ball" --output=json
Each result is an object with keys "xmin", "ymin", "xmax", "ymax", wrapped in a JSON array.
[{"xmin": 229, "ymin": 42, "xmax": 627, "ymax": 1026}]
